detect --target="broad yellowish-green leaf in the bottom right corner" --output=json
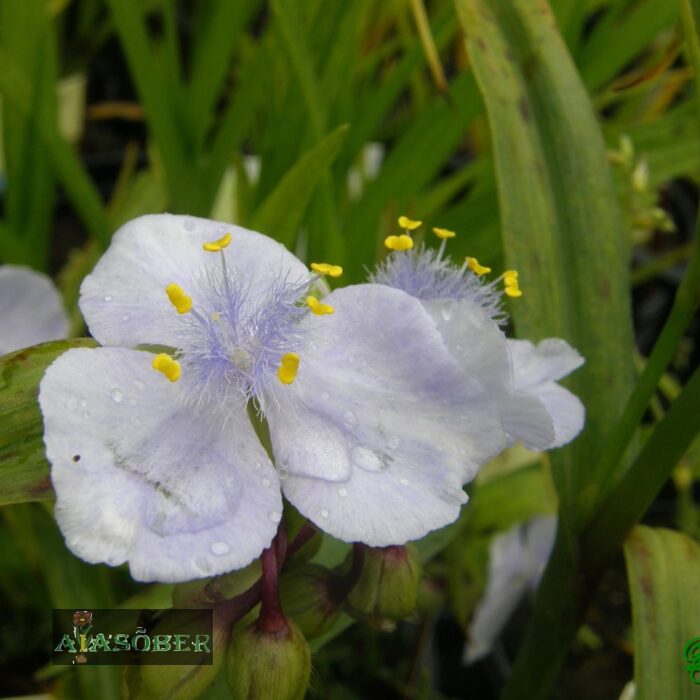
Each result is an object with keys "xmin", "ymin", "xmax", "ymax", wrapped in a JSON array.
[{"xmin": 625, "ymin": 526, "xmax": 700, "ymax": 700}]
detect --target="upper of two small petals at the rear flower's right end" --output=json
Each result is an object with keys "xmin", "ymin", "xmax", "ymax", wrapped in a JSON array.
[{"xmin": 508, "ymin": 338, "xmax": 584, "ymax": 390}]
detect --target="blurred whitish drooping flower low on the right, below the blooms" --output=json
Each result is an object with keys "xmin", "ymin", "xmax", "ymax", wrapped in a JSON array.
[{"xmin": 464, "ymin": 516, "xmax": 557, "ymax": 663}]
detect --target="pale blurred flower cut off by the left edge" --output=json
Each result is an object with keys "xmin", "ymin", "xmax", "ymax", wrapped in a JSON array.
[{"xmin": 0, "ymin": 265, "xmax": 69, "ymax": 355}]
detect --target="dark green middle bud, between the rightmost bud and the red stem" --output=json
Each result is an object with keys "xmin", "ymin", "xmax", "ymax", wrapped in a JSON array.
[{"xmin": 280, "ymin": 564, "xmax": 340, "ymax": 639}]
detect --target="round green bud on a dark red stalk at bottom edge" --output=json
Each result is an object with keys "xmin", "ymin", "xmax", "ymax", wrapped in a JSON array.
[{"xmin": 227, "ymin": 620, "xmax": 311, "ymax": 700}]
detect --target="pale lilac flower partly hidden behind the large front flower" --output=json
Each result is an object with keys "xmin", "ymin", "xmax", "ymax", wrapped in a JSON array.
[{"xmin": 370, "ymin": 217, "xmax": 585, "ymax": 450}]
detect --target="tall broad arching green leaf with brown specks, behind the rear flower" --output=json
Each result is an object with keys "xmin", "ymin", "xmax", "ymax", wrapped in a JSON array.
[{"xmin": 455, "ymin": 0, "xmax": 634, "ymax": 528}]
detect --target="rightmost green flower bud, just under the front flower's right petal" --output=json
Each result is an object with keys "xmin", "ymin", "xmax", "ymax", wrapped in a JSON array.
[{"xmin": 348, "ymin": 545, "xmax": 421, "ymax": 629}]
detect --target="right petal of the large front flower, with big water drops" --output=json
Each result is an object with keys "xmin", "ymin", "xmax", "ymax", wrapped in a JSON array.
[{"xmin": 266, "ymin": 285, "xmax": 505, "ymax": 546}]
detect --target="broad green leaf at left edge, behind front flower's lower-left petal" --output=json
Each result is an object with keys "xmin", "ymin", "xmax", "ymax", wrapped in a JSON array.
[{"xmin": 0, "ymin": 338, "xmax": 97, "ymax": 505}]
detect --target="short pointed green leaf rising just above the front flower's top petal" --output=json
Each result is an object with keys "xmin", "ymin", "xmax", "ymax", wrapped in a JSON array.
[{"xmin": 251, "ymin": 125, "xmax": 348, "ymax": 247}]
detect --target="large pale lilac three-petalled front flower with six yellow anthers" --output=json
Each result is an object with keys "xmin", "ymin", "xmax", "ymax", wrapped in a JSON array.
[{"xmin": 39, "ymin": 215, "xmax": 506, "ymax": 581}]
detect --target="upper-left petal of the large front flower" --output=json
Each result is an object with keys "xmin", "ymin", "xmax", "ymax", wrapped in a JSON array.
[{"xmin": 80, "ymin": 214, "xmax": 309, "ymax": 347}]
